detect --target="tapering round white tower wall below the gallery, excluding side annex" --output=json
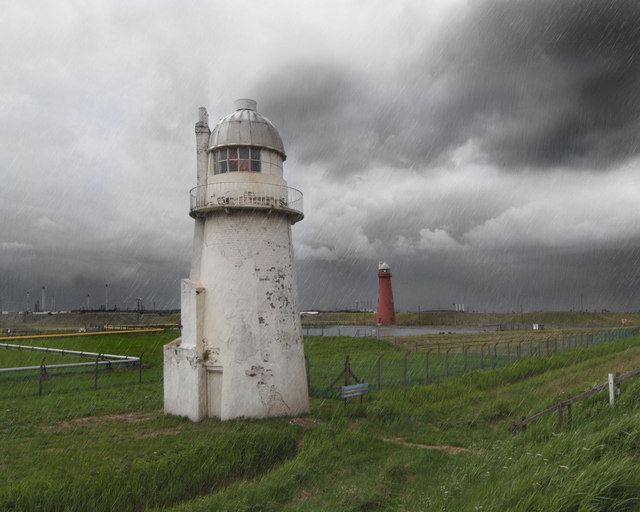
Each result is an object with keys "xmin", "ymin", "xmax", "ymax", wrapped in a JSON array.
[{"xmin": 200, "ymin": 210, "xmax": 309, "ymax": 419}]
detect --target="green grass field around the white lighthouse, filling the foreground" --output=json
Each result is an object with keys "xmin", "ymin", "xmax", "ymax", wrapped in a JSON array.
[{"xmin": 0, "ymin": 332, "xmax": 640, "ymax": 511}]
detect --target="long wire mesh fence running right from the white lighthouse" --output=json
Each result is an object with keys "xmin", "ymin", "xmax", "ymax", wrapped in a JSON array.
[{"xmin": 307, "ymin": 329, "xmax": 640, "ymax": 398}]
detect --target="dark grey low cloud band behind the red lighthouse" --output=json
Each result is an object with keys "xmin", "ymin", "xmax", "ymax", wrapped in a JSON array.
[{"xmin": 297, "ymin": 236, "xmax": 640, "ymax": 312}]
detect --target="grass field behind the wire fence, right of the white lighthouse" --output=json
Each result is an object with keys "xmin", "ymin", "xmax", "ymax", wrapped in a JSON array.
[{"xmin": 305, "ymin": 329, "xmax": 638, "ymax": 398}]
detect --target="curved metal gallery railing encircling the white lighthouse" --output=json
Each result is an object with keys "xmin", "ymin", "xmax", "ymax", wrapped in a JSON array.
[{"xmin": 189, "ymin": 182, "xmax": 304, "ymax": 222}]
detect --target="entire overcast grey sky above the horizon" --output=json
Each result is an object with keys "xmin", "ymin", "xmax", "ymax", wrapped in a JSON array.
[{"xmin": 0, "ymin": 0, "xmax": 640, "ymax": 311}]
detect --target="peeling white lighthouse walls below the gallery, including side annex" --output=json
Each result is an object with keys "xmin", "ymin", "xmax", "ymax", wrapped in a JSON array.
[{"xmin": 164, "ymin": 210, "xmax": 309, "ymax": 421}]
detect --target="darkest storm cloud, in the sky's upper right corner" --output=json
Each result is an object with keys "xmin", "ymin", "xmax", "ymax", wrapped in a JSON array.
[{"xmin": 461, "ymin": 0, "xmax": 640, "ymax": 167}]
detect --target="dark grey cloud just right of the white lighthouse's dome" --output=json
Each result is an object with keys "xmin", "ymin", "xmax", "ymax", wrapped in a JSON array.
[{"xmin": 259, "ymin": 62, "xmax": 438, "ymax": 177}]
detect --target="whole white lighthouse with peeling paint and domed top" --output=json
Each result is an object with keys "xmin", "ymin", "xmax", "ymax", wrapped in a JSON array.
[{"xmin": 164, "ymin": 99, "xmax": 309, "ymax": 421}]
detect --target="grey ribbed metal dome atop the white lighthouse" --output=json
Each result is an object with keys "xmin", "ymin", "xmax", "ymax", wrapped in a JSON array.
[{"xmin": 208, "ymin": 98, "xmax": 287, "ymax": 161}]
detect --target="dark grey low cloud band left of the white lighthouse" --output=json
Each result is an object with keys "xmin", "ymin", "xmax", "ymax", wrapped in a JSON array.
[{"xmin": 0, "ymin": 235, "xmax": 189, "ymax": 309}]
